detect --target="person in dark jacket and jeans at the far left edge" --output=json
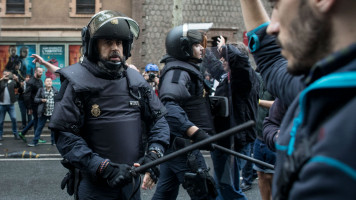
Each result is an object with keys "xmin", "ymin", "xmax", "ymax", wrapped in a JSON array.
[{"xmin": 0, "ymin": 70, "xmax": 20, "ymax": 141}]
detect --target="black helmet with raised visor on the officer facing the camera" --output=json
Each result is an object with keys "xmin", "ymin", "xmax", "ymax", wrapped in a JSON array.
[{"xmin": 82, "ymin": 10, "xmax": 140, "ymax": 61}]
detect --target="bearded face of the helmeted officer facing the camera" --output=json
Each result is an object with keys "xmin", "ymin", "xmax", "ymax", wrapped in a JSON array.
[{"xmin": 98, "ymin": 39, "xmax": 123, "ymax": 63}]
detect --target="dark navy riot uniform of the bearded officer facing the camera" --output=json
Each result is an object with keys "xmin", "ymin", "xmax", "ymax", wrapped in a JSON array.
[{"xmin": 49, "ymin": 58, "xmax": 169, "ymax": 199}]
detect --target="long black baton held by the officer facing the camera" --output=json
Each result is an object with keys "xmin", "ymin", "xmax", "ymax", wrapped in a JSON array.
[{"xmin": 131, "ymin": 120, "xmax": 255, "ymax": 175}]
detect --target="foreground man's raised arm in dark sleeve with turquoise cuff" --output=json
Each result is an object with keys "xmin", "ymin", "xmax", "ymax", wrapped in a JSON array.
[{"xmin": 240, "ymin": 0, "xmax": 305, "ymax": 105}]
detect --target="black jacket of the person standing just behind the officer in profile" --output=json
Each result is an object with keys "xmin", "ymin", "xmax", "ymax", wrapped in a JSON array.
[{"xmin": 204, "ymin": 45, "xmax": 260, "ymax": 149}]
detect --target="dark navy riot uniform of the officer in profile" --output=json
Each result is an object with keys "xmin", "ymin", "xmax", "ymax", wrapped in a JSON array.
[{"xmin": 153, "ymin": 57, "xmax": 215, "ymax": 199}]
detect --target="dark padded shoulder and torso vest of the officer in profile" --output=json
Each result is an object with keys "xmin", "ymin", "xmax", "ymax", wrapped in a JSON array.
[{"xmin": 160, "ymin": 60, "xmax": 215, "ymax": 134}]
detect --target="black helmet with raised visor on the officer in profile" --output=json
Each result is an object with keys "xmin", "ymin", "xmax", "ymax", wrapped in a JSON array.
[{"xmin": 166, "ymin": 23, "xmax": 212, "ymax": 60}]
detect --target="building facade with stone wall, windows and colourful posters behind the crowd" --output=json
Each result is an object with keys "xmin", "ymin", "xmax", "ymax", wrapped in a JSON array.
[{"xmin": 0, "ymin": 0, "xmax": 267, "ymax": 76}]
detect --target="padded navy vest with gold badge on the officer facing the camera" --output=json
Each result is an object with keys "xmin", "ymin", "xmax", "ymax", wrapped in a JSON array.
[{"xmin": 60, "ymin": 63, "xmax": 159, "ymax": 165}]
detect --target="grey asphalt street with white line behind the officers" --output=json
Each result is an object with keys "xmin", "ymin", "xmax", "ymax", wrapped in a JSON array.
[{"xmin": 0, "ymin": 122, "xmax": 261, "ymax": 200}]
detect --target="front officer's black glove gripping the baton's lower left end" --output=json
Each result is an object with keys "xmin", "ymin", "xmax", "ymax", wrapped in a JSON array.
[{"xmin": 99, "ymin": 162, "xmax": 132, "ymax": 188}]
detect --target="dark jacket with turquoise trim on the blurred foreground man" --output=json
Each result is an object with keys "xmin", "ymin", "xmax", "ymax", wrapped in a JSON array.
[{"xmin": 248, "ymin": 26, "xmax": 356, "ymax": 200}]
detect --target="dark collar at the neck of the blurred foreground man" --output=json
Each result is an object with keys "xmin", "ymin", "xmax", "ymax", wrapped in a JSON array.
[{"xmin": 305, "ymin": 43, "xmax": 356, "ymax": 85}]
